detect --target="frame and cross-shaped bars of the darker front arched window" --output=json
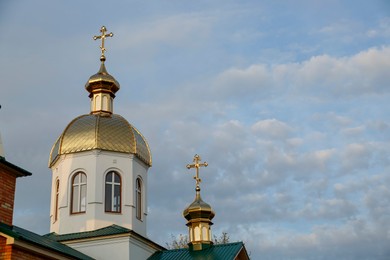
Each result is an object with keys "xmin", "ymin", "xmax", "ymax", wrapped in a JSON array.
[{"xmin": 104, "ymin": 170, "xmax": 122, "ymax": 214}]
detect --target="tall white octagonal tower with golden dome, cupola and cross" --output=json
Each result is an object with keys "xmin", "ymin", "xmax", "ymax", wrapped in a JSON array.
[{"xmin": 49, "ymin": 26, "xmax": 152, "ymax": 236}]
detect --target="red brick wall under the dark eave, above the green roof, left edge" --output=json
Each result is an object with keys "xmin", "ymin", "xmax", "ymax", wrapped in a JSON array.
[{"xmin": 0, "ymin": 168, "xmax": 16, "ymax": 225}]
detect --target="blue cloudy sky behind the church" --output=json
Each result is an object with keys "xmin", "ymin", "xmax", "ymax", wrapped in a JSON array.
[{"xmin": 0, "ymin": 0, "xmax": 390, "ymax": 259}]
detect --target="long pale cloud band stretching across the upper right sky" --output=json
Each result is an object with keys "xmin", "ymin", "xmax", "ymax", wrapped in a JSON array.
[{"xmin": 213, "ymin": 46, "xmax": 390, "ymax": 100}]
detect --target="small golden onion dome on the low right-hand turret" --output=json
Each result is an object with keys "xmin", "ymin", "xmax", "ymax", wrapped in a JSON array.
[{"xmin": 183, "ymin": 187, "xmax": 215, "ymax": 221}]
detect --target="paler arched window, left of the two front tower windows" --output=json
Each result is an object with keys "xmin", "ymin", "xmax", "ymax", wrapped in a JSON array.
[{"xmin": 71, "ymin": 172, "xmax": 87, "ymax": 213}]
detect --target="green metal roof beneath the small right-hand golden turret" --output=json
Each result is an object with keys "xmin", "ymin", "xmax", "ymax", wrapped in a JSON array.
[{"xmin": 148, "ymin": 242, "xmax": 245, "ymax": 260}]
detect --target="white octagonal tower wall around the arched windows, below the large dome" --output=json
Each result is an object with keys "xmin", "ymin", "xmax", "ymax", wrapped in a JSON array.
[{"xmin": 50, "ymin": 150, "xmax": 148, "ymax": 236}]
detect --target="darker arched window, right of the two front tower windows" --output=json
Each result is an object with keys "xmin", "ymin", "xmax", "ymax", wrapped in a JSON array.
[{"xmin": 104, "ymin": 171, "xmax": 121, "ymax": 212}]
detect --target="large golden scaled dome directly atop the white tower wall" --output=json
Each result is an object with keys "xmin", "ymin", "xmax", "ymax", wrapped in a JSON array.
[{"xmin": 49, "ymin": 114, "xmax": 152, "ymax": 167}]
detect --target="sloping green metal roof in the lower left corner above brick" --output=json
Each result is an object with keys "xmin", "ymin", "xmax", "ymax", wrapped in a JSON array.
[{"xmin": 0, "ymin": 223, "xmax": 94, "ymax": 260}]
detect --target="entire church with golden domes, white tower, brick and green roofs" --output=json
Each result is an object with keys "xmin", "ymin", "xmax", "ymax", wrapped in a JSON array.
[{"xmin": 0, "ymin": 26, "xmax": 249, "ymax": 260}]
